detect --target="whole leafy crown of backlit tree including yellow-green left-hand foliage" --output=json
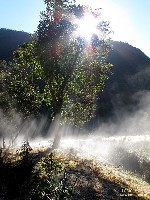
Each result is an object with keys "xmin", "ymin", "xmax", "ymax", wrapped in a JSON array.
[{"xmin": 9, "ymin": 0, "xmax": 112, "ymax": 127}]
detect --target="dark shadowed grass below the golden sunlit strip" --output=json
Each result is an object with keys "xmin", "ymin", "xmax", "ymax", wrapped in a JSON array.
[{"xmin": 67, "ymin": 165, "xmax": 144, "ymax": 200}]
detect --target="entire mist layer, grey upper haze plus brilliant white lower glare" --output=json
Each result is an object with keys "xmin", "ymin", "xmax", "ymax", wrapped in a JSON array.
[{"xmin": 0, "ymin": 91, "xmax": 150, "ymax": 181}]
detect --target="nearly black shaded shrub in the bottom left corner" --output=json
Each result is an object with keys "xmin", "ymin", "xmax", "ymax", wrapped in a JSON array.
[{"xmin": 0, "ymin": 142, "xmax": 34, "ymax": 200}]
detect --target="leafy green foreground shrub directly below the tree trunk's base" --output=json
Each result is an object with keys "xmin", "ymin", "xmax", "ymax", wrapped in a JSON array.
[{"xmin": 30, "ymin": 153, "xmax": 72, "ymax": 199}]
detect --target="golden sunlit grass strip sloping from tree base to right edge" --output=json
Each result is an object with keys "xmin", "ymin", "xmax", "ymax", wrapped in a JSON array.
[{"xmin": 52, "ymin": 148, "xmax": 150, "ymax": 199}]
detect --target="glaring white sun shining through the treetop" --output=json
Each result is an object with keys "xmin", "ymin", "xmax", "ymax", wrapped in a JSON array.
[{"xmin": 74, "ymin": 13, "xmax": 99, "ymax": 40}]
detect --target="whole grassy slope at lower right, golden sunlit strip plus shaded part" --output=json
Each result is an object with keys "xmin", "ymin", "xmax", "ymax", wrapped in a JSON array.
[{"xmin": 54, "ymin": 149, "xmax": 150, "ymax": 199}]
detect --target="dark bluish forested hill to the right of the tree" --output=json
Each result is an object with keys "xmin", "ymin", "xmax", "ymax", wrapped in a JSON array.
[{"xmin": 97, "ymin": 41, "xmax": 150, "ymax": 119}]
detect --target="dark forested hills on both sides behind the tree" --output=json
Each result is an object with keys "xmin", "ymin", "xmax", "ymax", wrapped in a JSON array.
[{"xmin": 0, "ymin": 29, "xmax": 150, "ymax": 122}]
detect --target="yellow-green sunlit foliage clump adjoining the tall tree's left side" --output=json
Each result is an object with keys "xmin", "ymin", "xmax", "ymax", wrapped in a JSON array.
[{"xmin": 9, "ymin": 43, "xmax": 42, "ymax": 117}]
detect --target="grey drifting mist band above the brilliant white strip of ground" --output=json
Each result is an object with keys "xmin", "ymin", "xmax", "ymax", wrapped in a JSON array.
[{"xmin": 0, "ymin": 91, "xmax": 150, "ymax": 144}]
